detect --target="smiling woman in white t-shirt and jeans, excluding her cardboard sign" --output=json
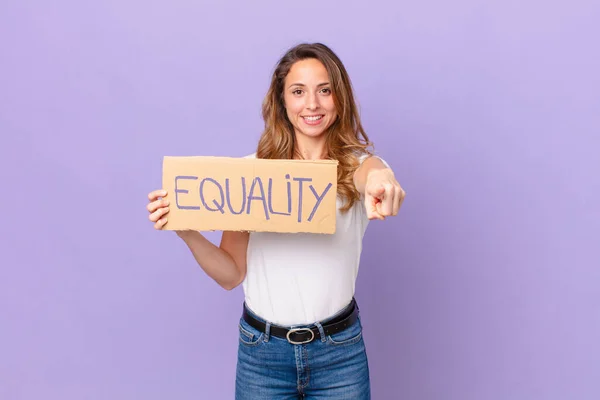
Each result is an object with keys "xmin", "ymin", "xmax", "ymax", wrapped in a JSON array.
[{"xmin": 148, "ymin": 43, "xmax": 404, "ymax": 399}]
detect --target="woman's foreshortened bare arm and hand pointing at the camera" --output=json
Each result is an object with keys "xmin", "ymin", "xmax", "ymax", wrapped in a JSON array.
[{"xmin": 354, "ymin": 157, "xmax": 406, "ymax": 220}]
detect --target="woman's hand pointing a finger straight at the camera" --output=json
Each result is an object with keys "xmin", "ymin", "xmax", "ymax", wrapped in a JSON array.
[{"xmin": 365, "ymin": 168, "xmax": 406, "ymax": 220}]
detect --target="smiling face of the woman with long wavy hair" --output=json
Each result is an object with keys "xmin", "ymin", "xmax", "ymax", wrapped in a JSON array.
[{"xmin": 283, "ymin": 58, "xmax": 337, "ymax": 138}]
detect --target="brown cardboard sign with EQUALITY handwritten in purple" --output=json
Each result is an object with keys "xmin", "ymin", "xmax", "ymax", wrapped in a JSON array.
[{"xmin": 163, "ymin": 157, "xmax": 338, "ymax": 234}]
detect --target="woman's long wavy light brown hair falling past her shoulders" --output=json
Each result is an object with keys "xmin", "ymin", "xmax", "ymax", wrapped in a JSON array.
[{"xmin": 256, "ymin": 43, "xmax": 372, "ymax": 212}]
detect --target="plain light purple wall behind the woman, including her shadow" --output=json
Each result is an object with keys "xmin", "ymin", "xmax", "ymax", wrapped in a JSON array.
[{"xmin": 0, "ymin": 0, "xmax": 600, "ymax": 400}]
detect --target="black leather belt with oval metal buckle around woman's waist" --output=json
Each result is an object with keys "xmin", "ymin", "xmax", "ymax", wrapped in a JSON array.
[{"xmin": 242, "ymin": 299, "xmax": 358, "ymax": 344}]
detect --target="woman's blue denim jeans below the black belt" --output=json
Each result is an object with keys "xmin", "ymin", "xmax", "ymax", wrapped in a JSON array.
[{"xmin": 235, "ymin": 304, "xmax": 371, "ymax": 400}]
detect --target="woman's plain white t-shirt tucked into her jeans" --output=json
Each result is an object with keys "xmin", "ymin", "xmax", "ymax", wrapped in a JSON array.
[{"xmin": 242, "ymin": 154, "xmax": 384, "ymax": 326}]
